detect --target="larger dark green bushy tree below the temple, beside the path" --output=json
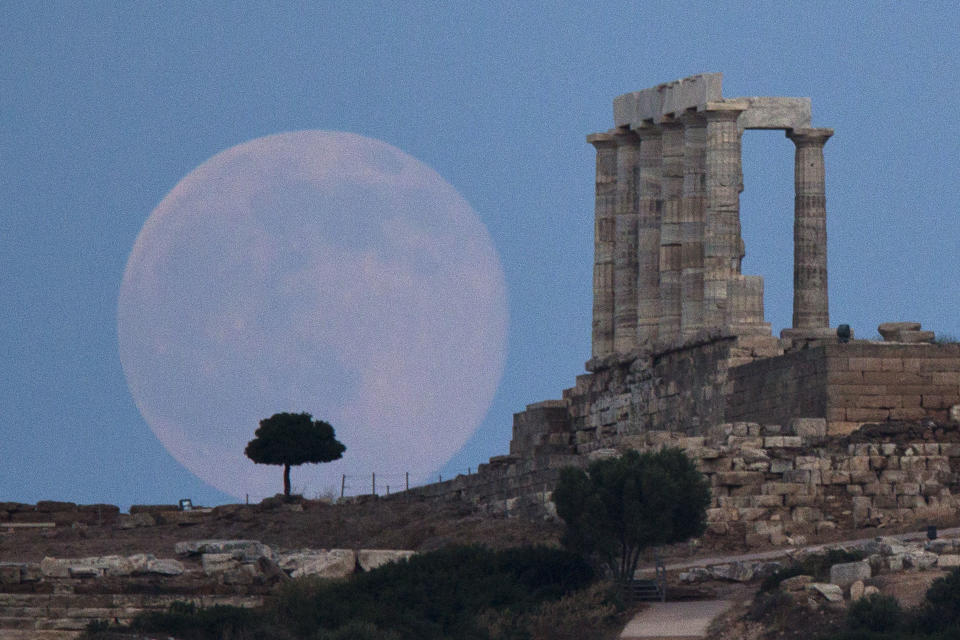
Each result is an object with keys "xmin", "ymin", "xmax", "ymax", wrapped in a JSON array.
[{"xmin": 553, "ymin": 449, "xmax": 710, "ymax": 581}]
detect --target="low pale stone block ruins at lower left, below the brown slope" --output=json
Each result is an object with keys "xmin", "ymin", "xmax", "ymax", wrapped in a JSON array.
[{"xmin": 0, "ymin": 540, "xmax": 414, "ymax": 638}]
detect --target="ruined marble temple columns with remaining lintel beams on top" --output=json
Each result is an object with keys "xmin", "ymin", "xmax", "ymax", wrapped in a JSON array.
[{"xmin": 587, "ymin": 73, "xmax": 833, "ymax": 359}]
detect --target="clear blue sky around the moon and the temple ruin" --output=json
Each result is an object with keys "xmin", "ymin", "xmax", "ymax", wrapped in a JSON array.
[{"xmin": 0, "ymin": 1, "xmax": 960, "ymax": 504}]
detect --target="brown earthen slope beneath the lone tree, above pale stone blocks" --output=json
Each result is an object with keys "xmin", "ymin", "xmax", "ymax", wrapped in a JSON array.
[{"xmin": 0, "ymin": 498, "xmax": 562, "ymax": 562}]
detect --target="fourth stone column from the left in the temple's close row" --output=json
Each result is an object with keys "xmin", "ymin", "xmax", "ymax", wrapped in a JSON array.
[{"xmin": 658, "ymin": 120, "xmax": 683, "ymax": 340}]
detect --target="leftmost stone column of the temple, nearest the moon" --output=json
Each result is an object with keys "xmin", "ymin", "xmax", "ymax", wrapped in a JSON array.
[{"xmin": 587, "ymin": 133, "xmax": 617, "ymax": 358}]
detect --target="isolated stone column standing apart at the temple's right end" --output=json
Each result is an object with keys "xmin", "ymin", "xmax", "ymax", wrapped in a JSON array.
[{"xmin": 787, "ymin": 129, "xmax": 833, "ymax": 329}]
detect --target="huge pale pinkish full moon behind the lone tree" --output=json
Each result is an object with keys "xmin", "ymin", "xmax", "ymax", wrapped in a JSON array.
[{"xmin": 117, "ymin": 130, "xmax": 507, "ymax": 498}]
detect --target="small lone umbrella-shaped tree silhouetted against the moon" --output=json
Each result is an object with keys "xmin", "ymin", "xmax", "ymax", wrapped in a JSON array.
[{"xmin": 243, "ymin": 413, "xmax": 347, "ymax": 496}]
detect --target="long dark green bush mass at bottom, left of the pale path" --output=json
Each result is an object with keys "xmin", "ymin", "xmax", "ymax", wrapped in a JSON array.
[{"xmin": 276, "ymin": 546, "xmax": 594, "ymax": 640}]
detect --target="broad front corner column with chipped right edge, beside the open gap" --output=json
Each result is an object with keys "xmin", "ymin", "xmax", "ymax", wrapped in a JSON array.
[{"xmin": 703, "ymin": 101, "xmax": 749, "ymax": 328}]
